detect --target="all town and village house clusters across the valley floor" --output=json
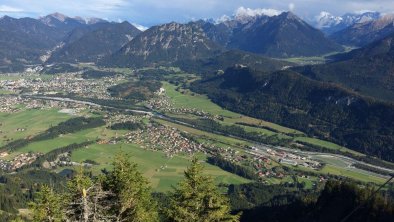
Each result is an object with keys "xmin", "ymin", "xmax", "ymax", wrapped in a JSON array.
[{"xmin": 0, "ymin": 73, "xmax": 321, "ymax": 184}]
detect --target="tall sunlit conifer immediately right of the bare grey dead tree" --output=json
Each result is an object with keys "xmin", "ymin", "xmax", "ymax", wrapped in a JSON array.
[{"xmin": 104, "ymin": 153, "xmax": 159, "ymax": 222}]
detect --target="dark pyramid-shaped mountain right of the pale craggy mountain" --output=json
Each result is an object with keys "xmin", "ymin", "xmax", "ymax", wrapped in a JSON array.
[{"xmin": 199, "ymin": 12, "xmax": 342, "ymax": 57}]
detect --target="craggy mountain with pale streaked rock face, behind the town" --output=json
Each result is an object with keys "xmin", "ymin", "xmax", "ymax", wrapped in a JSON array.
[{"xmin": 102, "ymin": 22, "xmax": 222, "ymax": 66}]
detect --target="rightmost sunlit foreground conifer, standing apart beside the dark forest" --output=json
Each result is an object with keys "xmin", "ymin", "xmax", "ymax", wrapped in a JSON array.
[{"xmin": 166, "ymin": 158, "xmax": 239, "ymax": 222}]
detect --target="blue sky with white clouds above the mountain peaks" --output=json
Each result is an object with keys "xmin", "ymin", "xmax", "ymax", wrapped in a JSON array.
[{"xmin": 0, "ymin": 0, "xmax": 394, "ymax": 26}]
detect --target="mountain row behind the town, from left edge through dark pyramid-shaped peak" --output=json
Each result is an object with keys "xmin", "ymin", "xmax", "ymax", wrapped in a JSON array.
[{"xmin": 0, "ymin": 12, "xmax": 348, "ymax": 71}]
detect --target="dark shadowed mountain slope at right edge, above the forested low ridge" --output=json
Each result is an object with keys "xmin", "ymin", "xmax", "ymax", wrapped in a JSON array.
[{"xmin": 294, "ymin": 33, "xmax": 394, "ymax": 101}]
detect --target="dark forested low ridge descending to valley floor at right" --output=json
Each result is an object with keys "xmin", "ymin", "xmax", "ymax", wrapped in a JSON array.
[{"xmin": 190, "ymin": 67, "xmax": 394, "ymax": 161}]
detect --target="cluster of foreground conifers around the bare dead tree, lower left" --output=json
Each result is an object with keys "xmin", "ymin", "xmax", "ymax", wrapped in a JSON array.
[{"xmin": 31, "ymin": 154, "xmax": 159, "ymax": 222}]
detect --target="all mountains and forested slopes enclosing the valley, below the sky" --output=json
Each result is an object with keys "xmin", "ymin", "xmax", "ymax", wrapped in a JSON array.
[{"xmin": 0, "ymin": 12, "xmax": 394, "ymax": 163}]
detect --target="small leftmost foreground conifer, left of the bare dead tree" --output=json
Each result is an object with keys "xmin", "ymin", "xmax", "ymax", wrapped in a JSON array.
[{"xmin": 30, "ymin": 185, "xmax": 64, "ymax": 222}]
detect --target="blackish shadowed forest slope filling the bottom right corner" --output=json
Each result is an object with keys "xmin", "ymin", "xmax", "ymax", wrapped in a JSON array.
[{"xmin": 228, "ymin": 180, "xmax": 394, "ymax": 222}]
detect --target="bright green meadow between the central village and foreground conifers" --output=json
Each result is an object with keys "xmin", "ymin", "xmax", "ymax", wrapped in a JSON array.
[{"xmin": 72, "ymin": 144, "xmax": 249, "ymax": 191}]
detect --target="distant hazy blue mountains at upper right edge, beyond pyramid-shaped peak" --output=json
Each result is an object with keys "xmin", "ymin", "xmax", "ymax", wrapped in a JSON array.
[{"xmin": 330, "ymin": 15, "xmax": 394, "ymax": 46}]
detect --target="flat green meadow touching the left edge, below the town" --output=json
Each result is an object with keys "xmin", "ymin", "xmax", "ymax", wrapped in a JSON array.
[{"xmin": 0, "ymin": 109, "xmax": 72, "ymax": 146}]
